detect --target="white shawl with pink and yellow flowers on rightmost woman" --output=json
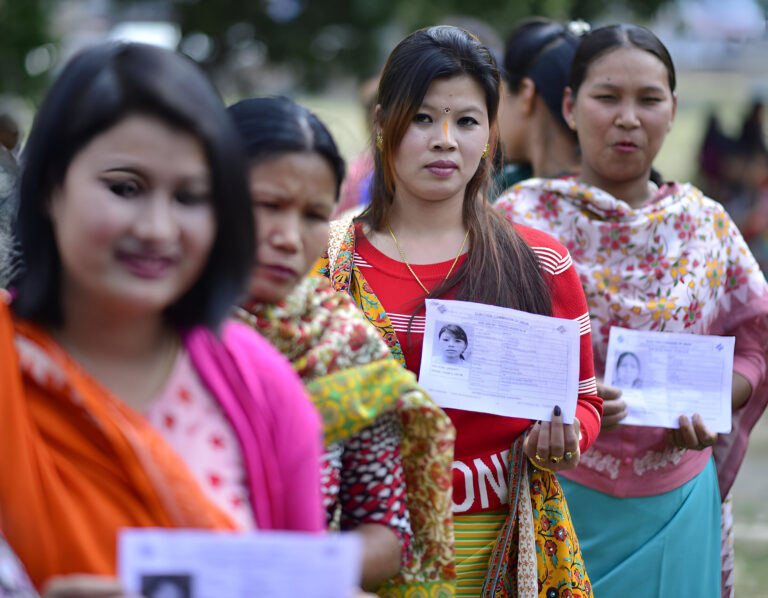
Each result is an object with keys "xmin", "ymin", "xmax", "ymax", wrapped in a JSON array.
[{"xmin": 496, "ymin": 179, "xmax": 768, "ymax": 496}]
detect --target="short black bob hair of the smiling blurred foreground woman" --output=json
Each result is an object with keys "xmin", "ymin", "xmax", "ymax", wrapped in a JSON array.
[{"xmin": 13, "ymin": 42, "xmax": 255, "ymax": 328}]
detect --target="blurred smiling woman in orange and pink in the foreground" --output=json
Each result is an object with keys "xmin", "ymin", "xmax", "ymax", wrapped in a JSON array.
[{"xmin": 0, "ymin": 44, "xmax": 325, "ymax": 593}]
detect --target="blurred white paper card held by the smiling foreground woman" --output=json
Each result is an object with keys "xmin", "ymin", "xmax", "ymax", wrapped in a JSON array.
[{"xmin": 117, "ymin": 528, "xmax": 361, "ymax": 598}]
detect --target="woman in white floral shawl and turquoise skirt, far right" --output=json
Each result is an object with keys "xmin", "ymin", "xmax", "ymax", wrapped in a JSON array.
[{"xmin": 497, "ymin": 25, "xmax": 768, "ymax": 597}]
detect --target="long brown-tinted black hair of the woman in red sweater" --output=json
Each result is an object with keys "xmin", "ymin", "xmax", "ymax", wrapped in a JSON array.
[{"xmin": 358, "ymin": 25, "xmax": 552, "ymax": 318}]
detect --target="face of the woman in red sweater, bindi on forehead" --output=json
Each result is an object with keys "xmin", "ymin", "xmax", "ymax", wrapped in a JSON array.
[{"xmin": 394, "ymin": 75, "xmax": 490, "ymax": 209}]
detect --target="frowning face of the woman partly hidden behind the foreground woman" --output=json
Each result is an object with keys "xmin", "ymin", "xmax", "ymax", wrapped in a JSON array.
[{"xmin": 250, "ymin": 152, "xmax": 336, "ymax": 303}]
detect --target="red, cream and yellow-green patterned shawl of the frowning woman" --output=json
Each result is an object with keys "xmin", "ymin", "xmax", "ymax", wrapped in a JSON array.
[{"xmin": 238, "ymin": 277, "xmax": 455, "ymax": 598}]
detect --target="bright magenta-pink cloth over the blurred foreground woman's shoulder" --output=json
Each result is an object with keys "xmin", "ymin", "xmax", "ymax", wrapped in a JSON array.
[{"xmin": 185, "ymin": 322, "xmax": 325, "ymax": 531}]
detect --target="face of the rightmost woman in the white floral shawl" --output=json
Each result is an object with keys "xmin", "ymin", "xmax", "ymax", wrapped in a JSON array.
[{"xmin": 563, "ymin": 47, "xmax": 677, "ymax": 189}]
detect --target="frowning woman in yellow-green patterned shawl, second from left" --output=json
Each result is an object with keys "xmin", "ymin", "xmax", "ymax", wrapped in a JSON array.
[{"xmin": 230, "ymin": 98, "xmax": 454, "ymax": 596}]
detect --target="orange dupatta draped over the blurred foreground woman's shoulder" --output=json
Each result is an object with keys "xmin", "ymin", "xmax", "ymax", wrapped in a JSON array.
[{"xmin": 0, "ymin": 302, "xmax": 234, "ymax": 588}]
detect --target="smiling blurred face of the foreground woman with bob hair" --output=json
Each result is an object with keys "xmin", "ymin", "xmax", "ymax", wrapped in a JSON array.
[{"xmin": 49, "ymin": 115, "xmax": 216, "ymax": 315}]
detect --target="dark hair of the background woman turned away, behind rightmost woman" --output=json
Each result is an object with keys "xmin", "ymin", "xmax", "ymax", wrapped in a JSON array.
[{"xmin": 502, "ymin": 17, "xmax": 579, "ymax": 134}]
